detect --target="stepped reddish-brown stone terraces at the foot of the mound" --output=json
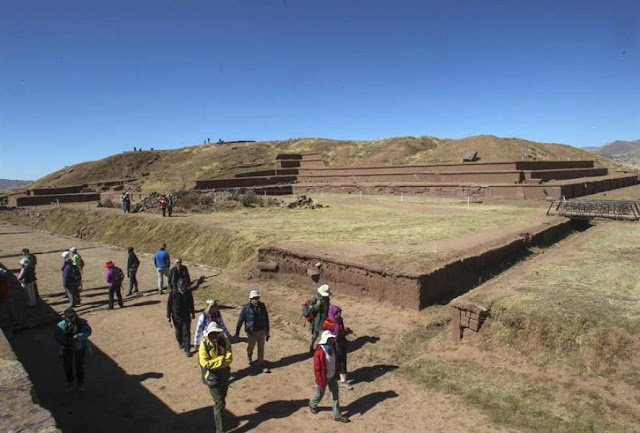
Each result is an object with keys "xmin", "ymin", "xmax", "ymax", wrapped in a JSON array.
[{"xmin": 196, "ymin": 154, "xmax": 638, "ymax": 200}]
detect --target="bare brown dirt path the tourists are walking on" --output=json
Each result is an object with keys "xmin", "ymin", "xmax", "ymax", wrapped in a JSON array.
[{"xmin": 0, "ymin": 224, "xmax": 505, "ymax": 433}]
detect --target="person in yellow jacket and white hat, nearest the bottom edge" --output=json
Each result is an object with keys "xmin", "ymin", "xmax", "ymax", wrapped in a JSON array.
[{"xmin": 198, "ymin": 322, "xmax": 233, "ymax": 433}]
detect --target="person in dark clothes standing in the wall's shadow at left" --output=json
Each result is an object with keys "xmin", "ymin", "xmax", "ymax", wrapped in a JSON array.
[{"xmin": 55, "ymin": 308, "xmax": 91, "ymax": 391}]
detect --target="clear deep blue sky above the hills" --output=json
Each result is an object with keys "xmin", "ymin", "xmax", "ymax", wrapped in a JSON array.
[{"xmin": 0, "ymin": 0, "xmax": 640, "ymax": 179}]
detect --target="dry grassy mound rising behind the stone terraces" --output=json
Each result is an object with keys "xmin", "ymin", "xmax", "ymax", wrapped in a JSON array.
[{"xmin": 28, "ymin": 135, "xmax": 616, "ymax": 191}]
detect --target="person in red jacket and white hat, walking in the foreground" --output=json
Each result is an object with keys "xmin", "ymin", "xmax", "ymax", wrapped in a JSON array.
[{"xmin": 309, "ymin": 331, "xmax": 349, "ymax": 423}]
